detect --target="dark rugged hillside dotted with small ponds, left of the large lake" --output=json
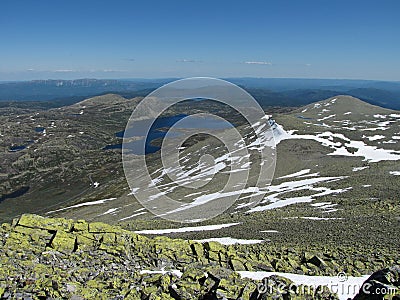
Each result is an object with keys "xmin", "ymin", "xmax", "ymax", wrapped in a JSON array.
[{"xmin": 0, "ymin": 95, "xmax": 140, "ymax": 223}]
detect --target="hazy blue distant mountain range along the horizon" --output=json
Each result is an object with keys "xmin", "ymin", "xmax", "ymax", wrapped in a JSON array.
[{"xmin": 0, "ymin": 78, "xmax": 400, "ymax": 110}]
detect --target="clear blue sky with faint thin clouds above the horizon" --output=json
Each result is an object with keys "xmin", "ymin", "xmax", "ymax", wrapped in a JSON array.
[{"xmin": 0, "ymin": 0, "xmax": 400, "ymax": 81}]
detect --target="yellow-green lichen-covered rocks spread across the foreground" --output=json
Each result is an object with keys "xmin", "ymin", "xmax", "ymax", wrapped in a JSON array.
[{"xmin": 0, "ymin": 215, "xmax": 357, "ymax": 300}]
